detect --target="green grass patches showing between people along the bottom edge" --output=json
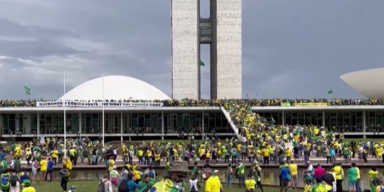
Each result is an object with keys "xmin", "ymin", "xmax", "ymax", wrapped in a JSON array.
[{"xmin": 26, "ymin": 181, "xmax": 303, "ymax": 192}]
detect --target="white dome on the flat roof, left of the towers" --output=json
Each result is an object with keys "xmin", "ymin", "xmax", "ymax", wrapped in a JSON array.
[{"xmin": 59, "ymin": 75, "xmax": 170, "ymax": 100}]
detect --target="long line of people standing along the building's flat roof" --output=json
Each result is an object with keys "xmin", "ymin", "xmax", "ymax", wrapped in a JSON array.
[{"xmin": 0, "ymin": 98, "xmax": 384, "ymax": 107}]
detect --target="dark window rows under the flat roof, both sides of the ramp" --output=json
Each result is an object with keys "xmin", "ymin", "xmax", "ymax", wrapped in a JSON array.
[{"xmin": 1, "ymin": 111, "xmax": 384, "ymax": 134}]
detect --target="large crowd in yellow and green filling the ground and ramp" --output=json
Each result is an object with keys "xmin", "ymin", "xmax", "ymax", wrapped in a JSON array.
[{"xmin": 0, "ymin": 131, "xmax": 384, "ymax": 192}]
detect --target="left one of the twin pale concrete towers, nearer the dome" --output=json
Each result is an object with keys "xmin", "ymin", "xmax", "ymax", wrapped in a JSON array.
[{"xmin": 171, "ymin": 0, "xmax": 200, "ymax": 99}]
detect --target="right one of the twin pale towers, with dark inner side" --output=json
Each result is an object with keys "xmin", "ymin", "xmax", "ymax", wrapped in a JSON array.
[{"xmin": 211, "ymin": 0, "xmax": 242, "ymax": 99}]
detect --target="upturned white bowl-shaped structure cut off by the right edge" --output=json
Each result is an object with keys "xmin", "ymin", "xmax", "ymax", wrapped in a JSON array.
[{"xmin": 340, "ymin": 68, "xmax": 384, "ymax": 98}]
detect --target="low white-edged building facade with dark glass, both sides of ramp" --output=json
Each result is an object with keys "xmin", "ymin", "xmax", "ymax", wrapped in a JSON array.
[{"xmin": 0, "ymin": 102, "xmax": 384, "ymax": 140}]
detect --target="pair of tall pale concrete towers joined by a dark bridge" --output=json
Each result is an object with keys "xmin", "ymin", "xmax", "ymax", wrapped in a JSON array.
[{"xmin": 171, "ymin": 0, "xmax": 242, "ymax": 99}]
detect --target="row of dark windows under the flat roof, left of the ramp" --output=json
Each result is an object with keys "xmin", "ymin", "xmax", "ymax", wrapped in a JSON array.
[{"xmin": 2, "ymin": 112, "xmax": 228, "ymax": 134}]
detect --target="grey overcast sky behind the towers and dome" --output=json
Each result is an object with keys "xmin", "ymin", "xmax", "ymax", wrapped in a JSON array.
[{"xmin": 0, "ymin": 0, "xmax": 384, "ymax": 99}]
